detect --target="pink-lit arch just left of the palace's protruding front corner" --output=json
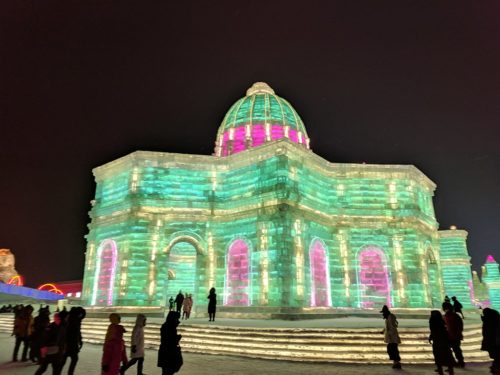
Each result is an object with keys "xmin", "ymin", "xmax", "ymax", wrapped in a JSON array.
[{"xmin": 224, "ymin": 239, "xmax": 250, "ymax": 306}]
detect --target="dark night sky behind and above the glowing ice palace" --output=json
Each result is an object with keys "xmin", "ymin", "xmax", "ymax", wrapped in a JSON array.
[{"xmin": 0, "ymin": 0, "xmax": 500, "ymax": 286}]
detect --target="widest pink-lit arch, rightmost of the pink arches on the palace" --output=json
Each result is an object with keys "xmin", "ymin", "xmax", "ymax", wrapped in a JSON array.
[{"xmin": 358, "ymin": 246, "xmax": 391, "ymax": 308}]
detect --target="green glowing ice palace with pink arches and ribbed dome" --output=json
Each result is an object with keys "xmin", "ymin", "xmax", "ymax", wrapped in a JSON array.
[{"xmin": 82, "ymin": 82, "xmax": 500, "ymax": 314}]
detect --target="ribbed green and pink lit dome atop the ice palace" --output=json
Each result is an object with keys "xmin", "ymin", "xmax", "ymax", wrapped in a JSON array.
[{"xmin": 215, "ymin": 82, "xmax": 309, "ymax": 156}]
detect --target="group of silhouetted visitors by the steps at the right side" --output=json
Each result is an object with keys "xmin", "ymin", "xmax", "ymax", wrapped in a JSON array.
[{"xmin": 380, "ymin": 296, "xmax": 500, "ymax": 375}]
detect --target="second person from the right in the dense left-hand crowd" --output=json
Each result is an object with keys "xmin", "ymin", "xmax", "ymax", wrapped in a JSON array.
[{"xmin": 35, "ymin": 313, "xmax": 66, "ymax": 375}]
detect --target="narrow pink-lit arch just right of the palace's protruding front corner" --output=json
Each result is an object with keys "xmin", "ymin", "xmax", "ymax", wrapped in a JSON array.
[{"xmin": 309, "ymin": 239, "xmax": 332, "ymax": 307}]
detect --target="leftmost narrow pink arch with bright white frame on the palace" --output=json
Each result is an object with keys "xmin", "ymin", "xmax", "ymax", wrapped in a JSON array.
[{"xmin": 91, "ymin": 240, "xmax": 118, "ymax": 306}]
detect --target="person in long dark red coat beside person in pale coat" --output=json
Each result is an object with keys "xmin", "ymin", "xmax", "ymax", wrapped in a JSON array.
[{"xmin": 101, "ymin": 313, "xmax": 128, "ymax": 375}]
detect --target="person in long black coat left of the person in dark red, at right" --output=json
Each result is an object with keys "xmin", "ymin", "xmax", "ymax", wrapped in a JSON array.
[{"xmin": 429, "ymin": 310, "xmax": 455, "ymax": 375}]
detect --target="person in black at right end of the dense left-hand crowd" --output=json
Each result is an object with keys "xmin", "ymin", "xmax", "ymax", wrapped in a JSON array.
[{"xmin": 61, "ymin": 307, "xmax": 86, "ymax": 375}]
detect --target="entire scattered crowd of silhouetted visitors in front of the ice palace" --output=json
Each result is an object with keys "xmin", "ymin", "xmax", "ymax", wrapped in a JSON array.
[{"xmin": 2, "ymin": 288, "xmax": 500, "ymax": 375}]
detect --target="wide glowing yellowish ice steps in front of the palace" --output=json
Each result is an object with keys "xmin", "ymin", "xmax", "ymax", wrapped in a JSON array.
[{"xmin": 0, "ymin": 314, "xmax": 490, "ymax": 364}]
